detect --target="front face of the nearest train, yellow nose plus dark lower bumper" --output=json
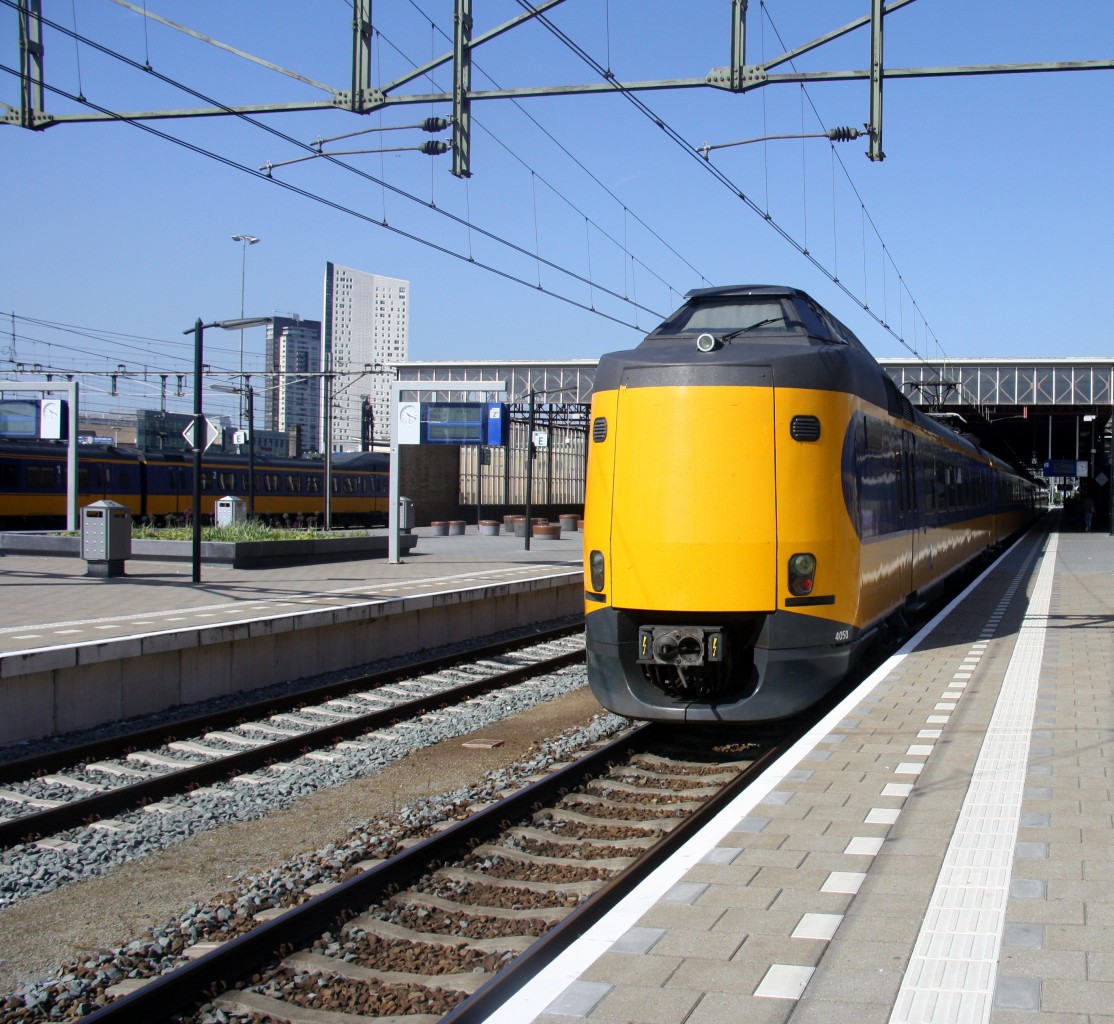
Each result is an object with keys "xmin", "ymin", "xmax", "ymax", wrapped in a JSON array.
[{"xmin": 585, "ymin": 367, "xmax": 862, "ymax": 722}]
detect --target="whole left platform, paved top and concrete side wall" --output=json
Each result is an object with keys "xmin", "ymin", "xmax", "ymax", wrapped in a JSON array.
[{"xmin": 0, "ymin": 527, "xmax": 584, "ymax": 744}]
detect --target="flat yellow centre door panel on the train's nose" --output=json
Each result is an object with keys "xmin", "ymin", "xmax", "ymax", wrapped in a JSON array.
[{"xmin": 609, "ymin": 387, "xmax": 776, "ymax": 612}]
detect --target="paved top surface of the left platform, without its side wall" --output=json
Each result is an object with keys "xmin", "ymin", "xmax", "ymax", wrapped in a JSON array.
[{"xmin": 0, "ymin": 527, "xmax": 583, "ymax": 653}]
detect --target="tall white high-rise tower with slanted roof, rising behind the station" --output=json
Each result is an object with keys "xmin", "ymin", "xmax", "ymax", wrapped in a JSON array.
[{"xmin": 321, "ymin": 263, "xmax": 410, "ymax": 451}]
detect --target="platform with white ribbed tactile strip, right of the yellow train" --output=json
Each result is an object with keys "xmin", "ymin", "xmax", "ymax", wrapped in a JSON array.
[{"xmin": 487, "ymin": 519, "xmax": 1114, "ymax": 1024}]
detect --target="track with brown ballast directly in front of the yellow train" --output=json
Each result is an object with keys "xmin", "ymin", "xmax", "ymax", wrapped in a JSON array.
[{"xmin": 71, "ymin": 725, "xmax": 799, "ymax": 1024}]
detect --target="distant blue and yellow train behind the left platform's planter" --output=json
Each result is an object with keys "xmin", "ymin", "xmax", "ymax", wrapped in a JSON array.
[{"xmin": 0, "ymin": 441, "xmax": 390, "ymax": 529}]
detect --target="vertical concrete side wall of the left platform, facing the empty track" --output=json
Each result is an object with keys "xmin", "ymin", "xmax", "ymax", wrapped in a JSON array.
[{"xmin": 0, "ymin": 572, "xmax": 584, "ymax": 743}]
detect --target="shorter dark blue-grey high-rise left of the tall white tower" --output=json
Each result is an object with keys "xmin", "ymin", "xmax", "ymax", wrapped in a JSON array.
[{"xmin": 263, "ymin": 315, "xmax": 322, "ymax": 451}]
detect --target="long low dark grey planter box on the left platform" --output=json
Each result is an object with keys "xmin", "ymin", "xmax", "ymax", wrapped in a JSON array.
[{"xmin": 0, "ymin": 533, "xmax": 418, "ymax": 569}]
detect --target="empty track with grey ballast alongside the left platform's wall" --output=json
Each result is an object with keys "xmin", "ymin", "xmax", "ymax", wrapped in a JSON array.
[{"xmin": 0, "ymin": 626, "xmax": 584, "ymax": 848}]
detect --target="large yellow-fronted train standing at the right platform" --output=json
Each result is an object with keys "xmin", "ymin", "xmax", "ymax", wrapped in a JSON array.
[{"xmin": 584, "ymin": 285, "xmax": 1043, "ymax": 723}]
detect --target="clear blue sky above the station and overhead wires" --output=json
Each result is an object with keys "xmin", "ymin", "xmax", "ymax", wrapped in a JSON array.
[{"xmin": 0, "ymin": 0, "xmax": 1114, "ymax": 421}]
